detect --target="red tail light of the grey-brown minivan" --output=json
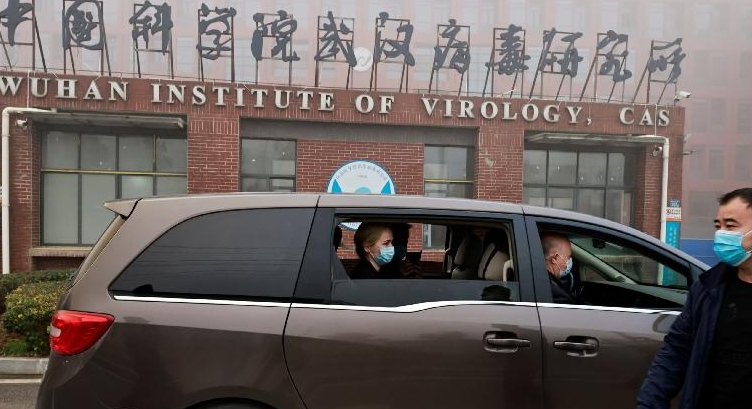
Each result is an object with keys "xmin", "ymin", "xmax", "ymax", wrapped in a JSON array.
[{"xmin": 50, "ymin": 310, "xmax": 115, "ymax": 355}]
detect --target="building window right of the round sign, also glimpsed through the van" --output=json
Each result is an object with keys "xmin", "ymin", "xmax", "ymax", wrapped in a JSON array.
[{"xmin": 423, "ymin": 146, "xmax": 475, "ymax": 248}]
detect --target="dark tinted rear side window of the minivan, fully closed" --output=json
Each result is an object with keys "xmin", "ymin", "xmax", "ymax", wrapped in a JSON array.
[{"xmin": 111, "ymin": 209, "xmax": 314, "ymax": 301}]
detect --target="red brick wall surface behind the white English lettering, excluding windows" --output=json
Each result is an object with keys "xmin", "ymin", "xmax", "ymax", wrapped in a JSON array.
[{"xmin": 0, "ymin": 72, "xmax": 684, "ymax": 270}]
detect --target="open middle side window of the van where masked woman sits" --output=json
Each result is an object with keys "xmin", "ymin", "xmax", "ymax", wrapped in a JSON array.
[{"xmin": 331, "ymin": 218, "xmax": 520, "ymax": 307}]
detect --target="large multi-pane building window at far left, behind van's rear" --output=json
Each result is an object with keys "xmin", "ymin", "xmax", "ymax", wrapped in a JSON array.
[{"xmin": 42, "ymin": 131, "xmax": 187, "ymax": 245}]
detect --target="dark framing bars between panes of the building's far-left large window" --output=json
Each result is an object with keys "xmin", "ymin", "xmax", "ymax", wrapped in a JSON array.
[{"xmin": 39, "ymin": 126, "xmax": 188, "ymax": 246}]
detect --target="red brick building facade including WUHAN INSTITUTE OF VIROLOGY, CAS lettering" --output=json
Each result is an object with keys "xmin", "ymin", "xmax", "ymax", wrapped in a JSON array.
[{"xmin": 0, "ymin": 72, "xmax": 684, "ymax": 271}]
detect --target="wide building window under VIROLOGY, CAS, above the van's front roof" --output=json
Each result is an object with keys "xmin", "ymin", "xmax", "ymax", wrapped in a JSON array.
[{"xmin": 522, "ymin": 149, "xmax": 634, "ymax": 225}]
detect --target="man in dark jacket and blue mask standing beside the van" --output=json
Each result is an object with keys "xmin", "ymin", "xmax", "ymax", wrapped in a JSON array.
[{"xmin": 637, "ymin": 188, "xmax": 752, "ymax": 409}]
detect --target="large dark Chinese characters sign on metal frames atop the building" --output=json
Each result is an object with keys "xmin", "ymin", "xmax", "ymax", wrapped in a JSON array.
[{"xmin": 0, "ymin": 0, "xmax": 686, "ymax": 102}]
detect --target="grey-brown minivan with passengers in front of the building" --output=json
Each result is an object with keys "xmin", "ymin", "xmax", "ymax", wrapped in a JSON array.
[{"xmin": 37, "ymin": 193, "xmax": 708, "ymax": 409}]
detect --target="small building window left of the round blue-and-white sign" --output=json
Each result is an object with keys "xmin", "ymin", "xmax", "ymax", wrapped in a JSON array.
[{"xmin": 240, "ymin": 139, "xmax": 296, "ymax": 192}]
